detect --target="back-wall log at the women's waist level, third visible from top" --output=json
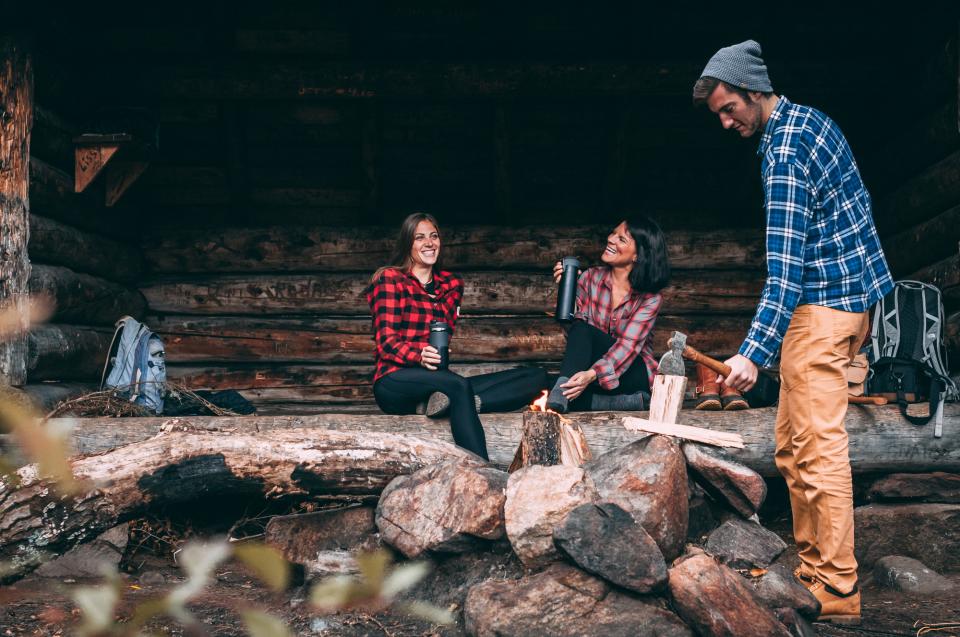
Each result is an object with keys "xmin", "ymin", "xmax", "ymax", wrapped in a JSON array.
[{"xmin": 147, "ymin": 315, "xmax": 750, "ymax": 364}]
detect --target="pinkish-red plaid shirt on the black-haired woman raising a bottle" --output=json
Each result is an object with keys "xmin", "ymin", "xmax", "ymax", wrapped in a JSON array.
[{"xmin": 575, "ymin": 266, "xmax": 663, "ymax": 389}]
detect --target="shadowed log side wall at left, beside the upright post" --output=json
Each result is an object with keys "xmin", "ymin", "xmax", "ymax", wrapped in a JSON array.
[{"xmin": 27, "ymin": 106, "xmax": 147, "ymax": 392}]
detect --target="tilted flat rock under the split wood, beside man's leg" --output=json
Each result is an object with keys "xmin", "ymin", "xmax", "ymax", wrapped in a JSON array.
[{"xmin": 683, "ymin": 442, "xmax": 767, "ymax": 518}]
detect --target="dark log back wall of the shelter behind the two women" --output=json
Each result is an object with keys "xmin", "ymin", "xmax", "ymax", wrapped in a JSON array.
[{"xmin": 26, "ymin": 3, "xmax": 955, "ymax": 413}]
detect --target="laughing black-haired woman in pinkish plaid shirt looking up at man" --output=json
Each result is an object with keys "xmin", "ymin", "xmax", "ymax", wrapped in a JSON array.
[{"xmin": 547, "ymin": 217, "xmax": 670, "ymax": 413}]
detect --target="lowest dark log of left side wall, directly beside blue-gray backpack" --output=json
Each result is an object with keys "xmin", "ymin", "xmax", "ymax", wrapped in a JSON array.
[{"xmin": 27, "ymin": 323, "xmax": 113, "ymax": 383}]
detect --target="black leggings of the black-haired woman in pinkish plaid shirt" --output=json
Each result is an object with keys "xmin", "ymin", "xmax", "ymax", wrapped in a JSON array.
[{"xmin": 560, "ymin": 321, "xmax": 650, "ymax": 410}]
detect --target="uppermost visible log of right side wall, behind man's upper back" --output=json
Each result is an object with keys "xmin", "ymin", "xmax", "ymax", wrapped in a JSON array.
[{"xmin": 874, "ymin": 151, "xmax": 960, "ymax": 237}]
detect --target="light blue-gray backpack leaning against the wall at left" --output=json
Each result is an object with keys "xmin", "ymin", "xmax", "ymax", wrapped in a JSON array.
[{"xmin": 100, "ymin": 316, "xmax": 167, "ymax": 415}]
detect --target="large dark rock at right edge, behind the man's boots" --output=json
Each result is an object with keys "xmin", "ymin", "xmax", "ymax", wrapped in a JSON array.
[{"xmin": 853, "ymin": 504, "xmax": 960, "ymax": 571}]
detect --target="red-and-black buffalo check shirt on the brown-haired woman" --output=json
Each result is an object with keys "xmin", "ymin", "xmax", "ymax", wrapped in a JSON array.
[{"xmin": 367, "ymin": 268, "xmax": 463, "ymax": 382}]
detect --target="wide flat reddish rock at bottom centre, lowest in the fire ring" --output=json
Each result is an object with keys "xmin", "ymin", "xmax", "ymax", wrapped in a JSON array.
[{"xmin": 464, "ymin": 564, "xmax": 693, "ymax": 637}]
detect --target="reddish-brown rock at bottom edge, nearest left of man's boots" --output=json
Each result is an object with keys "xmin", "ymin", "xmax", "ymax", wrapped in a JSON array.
[{"xmin": 669, "ymin": 554, "xmax": 790, "ymax": 637}]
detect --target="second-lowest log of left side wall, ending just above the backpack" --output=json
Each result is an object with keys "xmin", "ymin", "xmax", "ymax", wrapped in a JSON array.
[{"xmin": 30, "ymin": 265, "xmax": 147, "ymax": 325}]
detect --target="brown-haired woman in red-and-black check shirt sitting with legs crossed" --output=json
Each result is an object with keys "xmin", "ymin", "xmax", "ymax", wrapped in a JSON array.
[{"xmin": 367, "ymin": 212, "xmax": 547, "ymax": 460}]
